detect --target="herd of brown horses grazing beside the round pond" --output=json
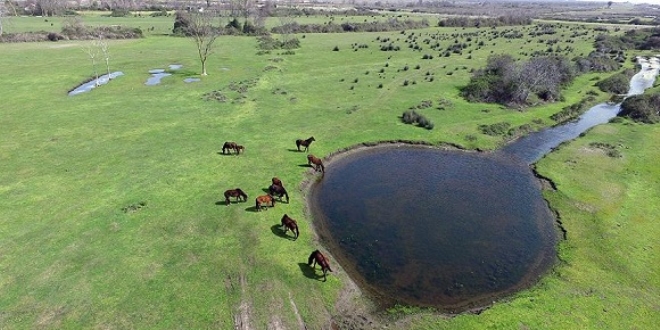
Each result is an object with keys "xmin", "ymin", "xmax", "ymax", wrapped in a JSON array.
[{"xmin": 222, "ymin": 136, "xmax": 332, "ymax": 282}]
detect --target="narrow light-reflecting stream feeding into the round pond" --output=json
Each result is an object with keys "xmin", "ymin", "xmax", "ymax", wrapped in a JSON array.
[{"xmin": 501, "ymin": 58, "xmax": 658, "ymax": 164}]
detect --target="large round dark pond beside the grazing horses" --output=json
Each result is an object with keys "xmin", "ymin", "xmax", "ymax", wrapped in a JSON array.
[{"xmin": 311, "ymin": 146, "xmax": 556, "ymax": 311}]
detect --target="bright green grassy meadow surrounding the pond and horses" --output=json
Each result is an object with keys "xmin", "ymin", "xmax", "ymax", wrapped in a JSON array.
[{"xmin": 0, "ymin": 11, "xmax": 660, "ymax": 329}]
